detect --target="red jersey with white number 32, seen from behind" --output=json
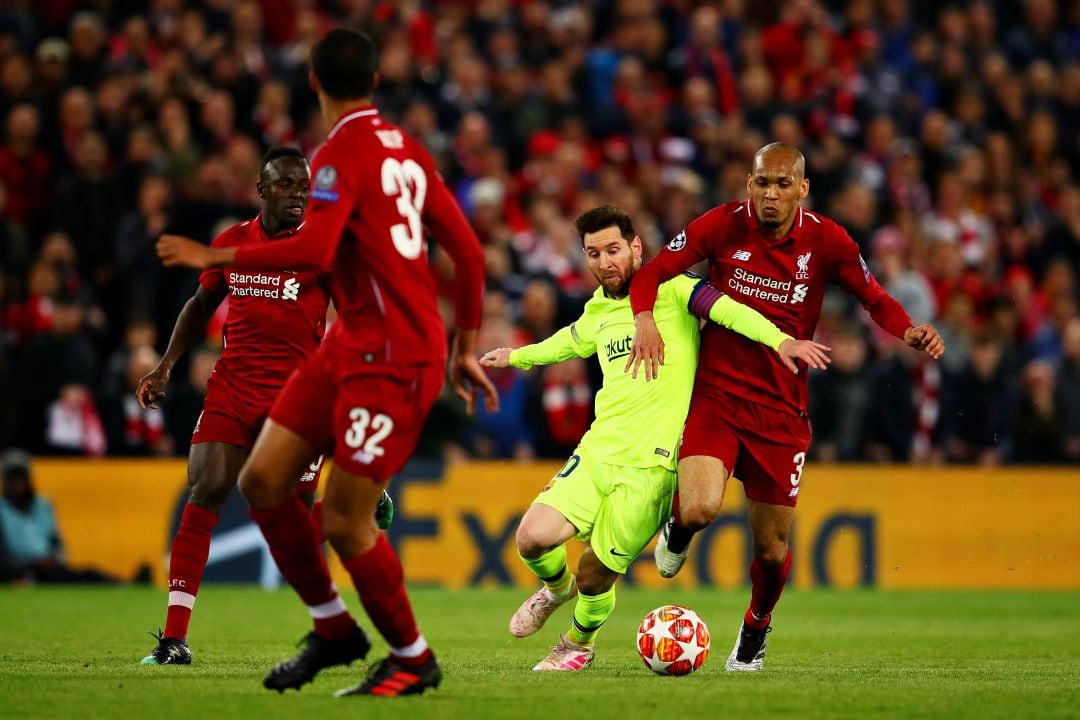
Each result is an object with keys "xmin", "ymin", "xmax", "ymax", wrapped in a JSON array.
[{"xmin": 235, "ymin": 107, "xmax": 484, "ymax": 363}]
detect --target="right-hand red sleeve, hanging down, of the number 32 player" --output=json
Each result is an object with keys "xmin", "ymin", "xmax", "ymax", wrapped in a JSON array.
[{"xmin": 413, "ymin": 142, "xmax": 485, "ymax": 330}]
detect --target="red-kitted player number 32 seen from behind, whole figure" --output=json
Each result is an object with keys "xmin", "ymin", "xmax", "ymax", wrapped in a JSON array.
[{"xmin": 158, "ymin": 29, "xmax": 498, "ymax": 695}]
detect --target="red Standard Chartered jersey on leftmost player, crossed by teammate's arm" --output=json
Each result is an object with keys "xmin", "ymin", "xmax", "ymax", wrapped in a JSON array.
[{"xmin": 199, "ymin": 217, "xmax": 329, "ymax": 400}]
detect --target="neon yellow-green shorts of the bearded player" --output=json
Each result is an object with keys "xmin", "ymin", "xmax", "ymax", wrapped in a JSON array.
[{"xmin": 534, "ymin": 448, "xmax": 675, "ymax": 573}]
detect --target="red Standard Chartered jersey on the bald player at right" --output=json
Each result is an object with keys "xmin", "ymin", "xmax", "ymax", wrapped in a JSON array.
[{"xmin": 630, "ymin": 201, "xmax": 912, "ymax": 412}]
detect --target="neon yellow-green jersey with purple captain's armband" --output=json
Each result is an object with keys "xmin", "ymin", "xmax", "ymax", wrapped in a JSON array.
[{"xmin": 510, "ymin": 275, "xmax": 788, "ymax": 470}]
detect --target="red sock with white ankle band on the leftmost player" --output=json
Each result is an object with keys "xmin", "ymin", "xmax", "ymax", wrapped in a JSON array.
[{"xmin": 165, "ymin": 503, "xmax": 217, "ymax": 640}]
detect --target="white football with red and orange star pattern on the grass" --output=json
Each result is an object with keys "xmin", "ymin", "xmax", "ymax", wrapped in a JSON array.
[{"xmin": 637, "ymin": 604, "xmax": 708, "ymax": 675}]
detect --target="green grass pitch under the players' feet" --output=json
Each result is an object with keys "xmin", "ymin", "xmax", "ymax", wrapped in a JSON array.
[{"xmin": 0, "ymin": 585, "xmax": 1080, "ymax": 720}]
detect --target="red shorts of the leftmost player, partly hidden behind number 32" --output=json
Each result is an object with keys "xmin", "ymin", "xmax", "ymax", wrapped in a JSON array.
[{"xmin": 191, "ymin": 372, "xmax": 323, "ymax": 492}]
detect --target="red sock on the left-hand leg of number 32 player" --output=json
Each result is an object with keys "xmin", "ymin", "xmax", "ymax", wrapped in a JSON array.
[{"xmin": 248, "ymin": 493, "xmax": 355, "ymax": 638}]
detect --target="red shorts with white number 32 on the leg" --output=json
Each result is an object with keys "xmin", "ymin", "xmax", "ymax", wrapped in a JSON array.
[{"xmin": 270, "ymin": 345, "xmax": 445, "ymax": 480}]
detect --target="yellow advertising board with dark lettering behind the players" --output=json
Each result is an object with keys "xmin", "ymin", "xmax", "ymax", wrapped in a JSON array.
[{"xmin": 23, "ymin": 459, "xmax": 1080, "ymax": 589}]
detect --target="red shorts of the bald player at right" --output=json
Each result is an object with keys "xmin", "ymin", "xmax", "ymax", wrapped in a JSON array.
[{"xmin": 679, "ymin": 392, "xmax": 810, "ymax": 507}]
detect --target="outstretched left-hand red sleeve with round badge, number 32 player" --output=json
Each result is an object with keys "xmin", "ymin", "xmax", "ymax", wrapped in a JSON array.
[{"xmin": 233, "ymin": 145, "xmax": 356, "ymax": 271}]
